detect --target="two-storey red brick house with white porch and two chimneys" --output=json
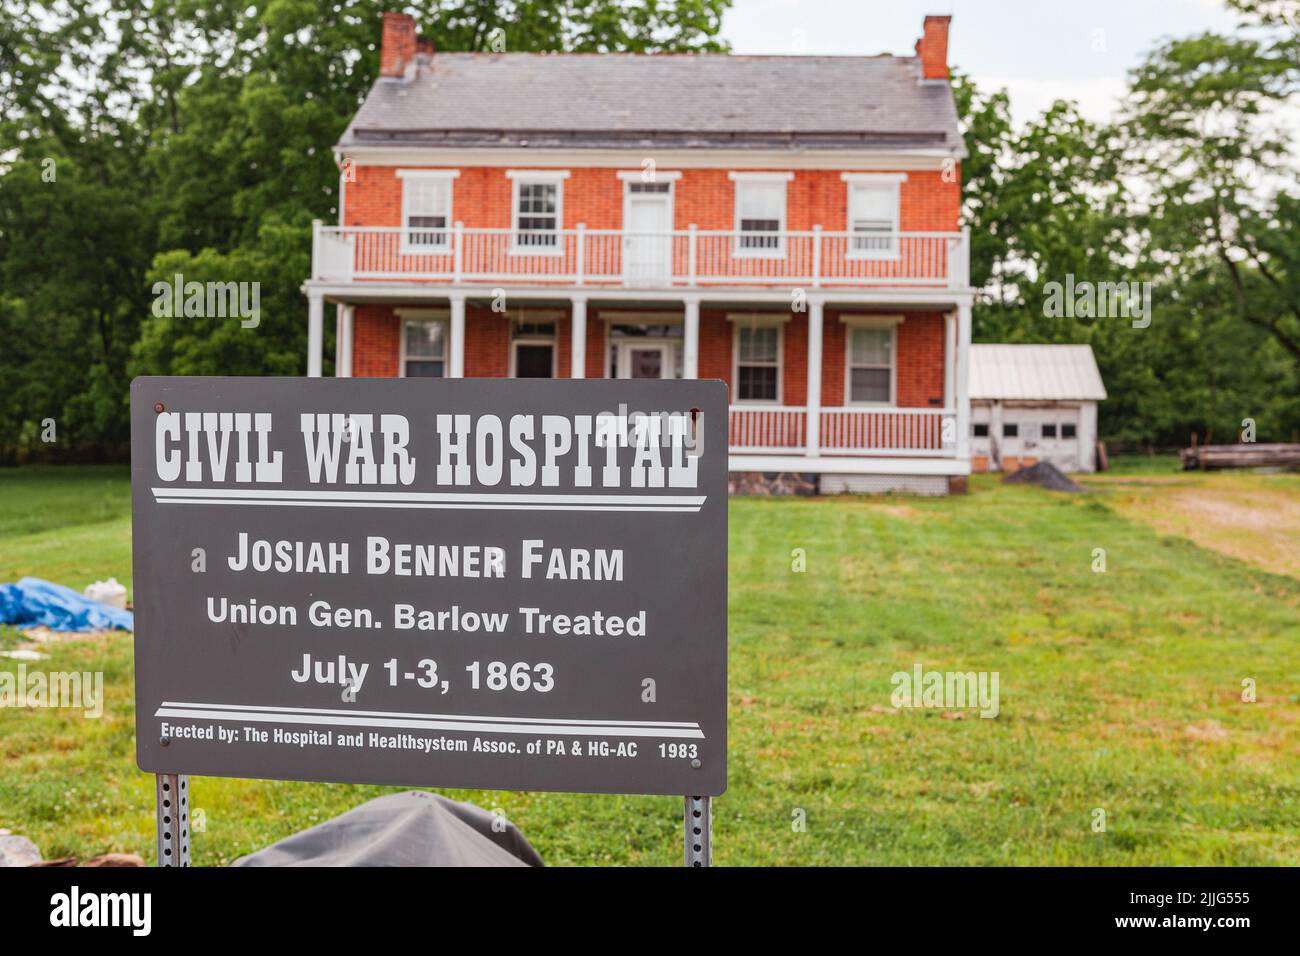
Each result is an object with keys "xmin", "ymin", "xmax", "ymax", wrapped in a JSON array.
[{"xmin": 304, "ymin": 13, "xmax": 972, "ymax": 493}]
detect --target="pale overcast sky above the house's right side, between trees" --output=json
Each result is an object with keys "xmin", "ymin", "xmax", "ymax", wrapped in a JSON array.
[{"xmin": 723, "ymin": 0, "xmax": 1236, "ymax": 120}]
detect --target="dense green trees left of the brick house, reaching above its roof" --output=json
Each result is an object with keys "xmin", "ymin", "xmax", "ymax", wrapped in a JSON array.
[{"xmin": 0, "ymin": 0, "xmax": 728, "ymax": 459}]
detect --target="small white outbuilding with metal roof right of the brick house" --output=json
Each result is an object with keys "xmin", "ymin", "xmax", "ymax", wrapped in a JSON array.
[{"xmin": 970, "ymin": 345, "xmax": 1106, "ymax": 471}]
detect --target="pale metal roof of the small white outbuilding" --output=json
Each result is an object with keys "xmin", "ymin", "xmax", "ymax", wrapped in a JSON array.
[{"xmin": 971, "ymin": 345, "xmax": 1106, "ymax": 402}]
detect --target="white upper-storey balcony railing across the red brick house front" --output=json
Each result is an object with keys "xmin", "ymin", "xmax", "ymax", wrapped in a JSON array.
[{"xmin": 312, "ymin": 224, "xmax": 970, "ymax": 289}]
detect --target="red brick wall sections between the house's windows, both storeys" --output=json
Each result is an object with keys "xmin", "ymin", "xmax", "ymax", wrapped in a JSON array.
[{"xmin": 345, "ymin": 165, "xmax": 961, "ymax": 398}]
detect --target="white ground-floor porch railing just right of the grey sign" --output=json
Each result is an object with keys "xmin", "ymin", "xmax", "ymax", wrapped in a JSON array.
[{"xmin": 728, "ymin": 405, "xmax": 957, "ymax": 458}]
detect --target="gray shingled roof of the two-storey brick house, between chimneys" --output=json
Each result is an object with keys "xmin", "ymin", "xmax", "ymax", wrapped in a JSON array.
[{"xmin": 339, "ymin": 53, "xmax": 963, "ymax": 155}]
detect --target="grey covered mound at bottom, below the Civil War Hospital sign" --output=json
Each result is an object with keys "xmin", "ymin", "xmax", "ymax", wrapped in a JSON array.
[{"xmin": 234, "ymin": 790, "xmax": 543, "ymax": 866}]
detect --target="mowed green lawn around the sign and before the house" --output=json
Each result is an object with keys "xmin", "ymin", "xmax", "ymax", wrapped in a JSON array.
[{"xmin": 0, "ymin": 470, "xmax": 1300, "ymax": 865}]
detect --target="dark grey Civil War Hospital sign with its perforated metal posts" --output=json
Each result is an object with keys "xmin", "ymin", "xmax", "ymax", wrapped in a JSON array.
[{"xmin": 131, "ymin": 377, "xmax": 727, "ymax": 865}]
